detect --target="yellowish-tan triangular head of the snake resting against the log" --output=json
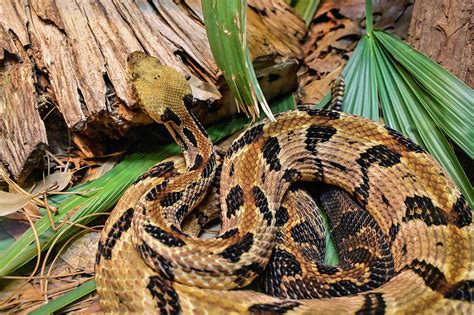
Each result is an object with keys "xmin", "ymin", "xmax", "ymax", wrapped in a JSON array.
[{"xmin": 127, "ymin": 51, "xmax": 192, "ymax": 123}]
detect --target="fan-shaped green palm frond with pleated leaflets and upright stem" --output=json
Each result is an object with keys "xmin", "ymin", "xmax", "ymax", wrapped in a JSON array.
[{"xmin": 343, "ymin": 1, "xmax": 474, "ymax": 207}]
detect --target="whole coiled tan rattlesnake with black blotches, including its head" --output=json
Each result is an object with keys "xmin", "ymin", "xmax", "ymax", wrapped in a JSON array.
[{"xmin": 96, "ymin": 52, "xmax": 474, "ymax": 314}]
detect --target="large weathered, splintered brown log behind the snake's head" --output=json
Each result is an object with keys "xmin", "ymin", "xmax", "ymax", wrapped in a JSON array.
[{"xmin": 0, "ymin": 0, "xmax": 305, "ymax": 181}]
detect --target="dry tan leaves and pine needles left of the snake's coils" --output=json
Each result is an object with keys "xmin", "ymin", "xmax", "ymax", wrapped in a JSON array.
[{"xmin": 0, "ymin": 152, "xmax": 101, "ymax": 313}]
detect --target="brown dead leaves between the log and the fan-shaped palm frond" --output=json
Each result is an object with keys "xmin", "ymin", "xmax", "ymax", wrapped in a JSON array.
[{"xmin": 299, "ymin": 0, "xmax": 413, "ymax": 105}]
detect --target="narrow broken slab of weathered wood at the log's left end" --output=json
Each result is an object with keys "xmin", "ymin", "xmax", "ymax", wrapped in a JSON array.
[{"xmin": 0, "ymin": 24, "xmax": 47, "ymax": 181}]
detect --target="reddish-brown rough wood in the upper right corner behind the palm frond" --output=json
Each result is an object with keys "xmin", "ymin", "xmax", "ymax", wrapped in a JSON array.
[{"xmin": 408, "ymin": 0, "xmax": 474, "ymax": 88}]
